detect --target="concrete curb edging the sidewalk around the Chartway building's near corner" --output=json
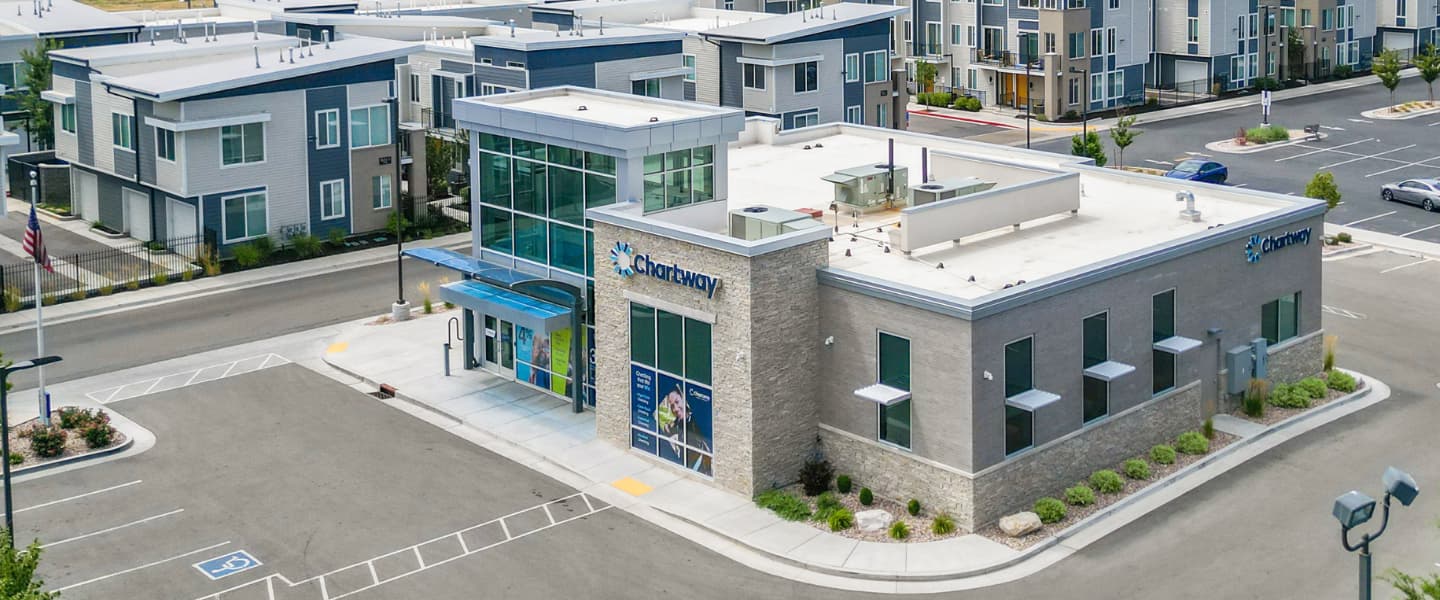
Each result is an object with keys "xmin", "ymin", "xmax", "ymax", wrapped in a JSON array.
[{"xmin": 651, "ymin": 371, "xmax": 1377, "ymax": 583}]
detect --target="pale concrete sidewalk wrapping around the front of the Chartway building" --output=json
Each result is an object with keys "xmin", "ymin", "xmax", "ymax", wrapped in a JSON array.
[{"xmin": 324, "ymin": 309, "xmax": 1388, "ymax": 593}]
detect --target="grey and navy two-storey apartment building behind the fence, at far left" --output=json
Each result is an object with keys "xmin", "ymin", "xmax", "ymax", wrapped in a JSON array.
[{"xmin": 45, "ymin": 33, "xmax": 423, "ymax": 252}]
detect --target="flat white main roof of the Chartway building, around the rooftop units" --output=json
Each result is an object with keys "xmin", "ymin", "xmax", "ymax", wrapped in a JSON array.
[{"xmin": 725, "ymin": 126, "xmax": 1295, "ymax": 299}]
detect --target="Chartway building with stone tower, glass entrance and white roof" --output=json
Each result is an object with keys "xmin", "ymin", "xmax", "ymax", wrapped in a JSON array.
[{"xmin": 419, "ymin": 88, "xmax": 1325, "ymax": 529}]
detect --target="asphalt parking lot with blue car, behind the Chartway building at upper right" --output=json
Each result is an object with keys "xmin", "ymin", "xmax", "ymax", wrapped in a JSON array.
[{"xmin": 1035, "ymin": 78, "xmax": 1440, "ymax": 242}]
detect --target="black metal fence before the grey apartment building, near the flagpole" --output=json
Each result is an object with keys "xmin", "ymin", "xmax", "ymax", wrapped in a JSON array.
[{"xmin": 0, "ymin": 235, "xmax": 205, "ymax": 312}]
